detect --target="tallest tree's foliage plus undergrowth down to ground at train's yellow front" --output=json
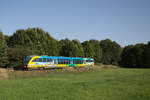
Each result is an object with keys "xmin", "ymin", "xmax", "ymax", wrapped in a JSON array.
[{"xmin": 5, "ymin": 28, "xmax": 59, "ymax": 67}]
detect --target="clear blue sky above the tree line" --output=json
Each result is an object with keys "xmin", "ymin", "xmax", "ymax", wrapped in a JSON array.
[{"xmin": 0, "ymin": 0, "xmax": 150, "ymax": 46}]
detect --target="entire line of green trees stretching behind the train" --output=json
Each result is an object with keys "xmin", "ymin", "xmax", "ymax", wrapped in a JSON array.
[{"xmin": 0, "ymin": 28, "xmax": 150, "ymax": 68}]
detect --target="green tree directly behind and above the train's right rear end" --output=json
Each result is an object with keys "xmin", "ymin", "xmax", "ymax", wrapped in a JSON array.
[{"xmin": 82, "ymin": 41, "xmax": 95, "ymax": 58}]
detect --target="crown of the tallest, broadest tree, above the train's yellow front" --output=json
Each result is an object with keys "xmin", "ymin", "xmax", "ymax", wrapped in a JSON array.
[{"xmin": 8, "ymin": 28, "xmax": 59, "ymax": 56}]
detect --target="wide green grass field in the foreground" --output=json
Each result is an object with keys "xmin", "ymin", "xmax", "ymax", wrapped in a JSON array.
[{"xmin": 0, "ymin": 68, "xmax": 150, "ymax": 100}]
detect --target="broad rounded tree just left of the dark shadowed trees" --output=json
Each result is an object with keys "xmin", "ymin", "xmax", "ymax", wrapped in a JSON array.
[{"xmin": 100, "ymin": 39, "xmax": 122, "ymax": 65}]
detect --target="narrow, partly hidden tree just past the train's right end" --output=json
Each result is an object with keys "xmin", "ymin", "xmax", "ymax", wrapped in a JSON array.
[{"xmin": 89, "ymin": 40, "xmax": 102, "ymax": 63}]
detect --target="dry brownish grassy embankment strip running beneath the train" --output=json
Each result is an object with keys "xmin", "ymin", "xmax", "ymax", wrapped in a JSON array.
[{"xmin": 0, "ymin": 65, "xmax": 119, "ymax": 79}]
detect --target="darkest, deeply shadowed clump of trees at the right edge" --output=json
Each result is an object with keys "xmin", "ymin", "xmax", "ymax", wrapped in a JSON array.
[{"xmin": 121, "ymin": 43, "xmax": 150, "ymax": 68}]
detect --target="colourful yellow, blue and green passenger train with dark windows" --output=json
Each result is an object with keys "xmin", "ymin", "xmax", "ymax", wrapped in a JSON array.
[{"xmin": 24, "ymin": 56, "xmax": 94, "ymax": 69}]
